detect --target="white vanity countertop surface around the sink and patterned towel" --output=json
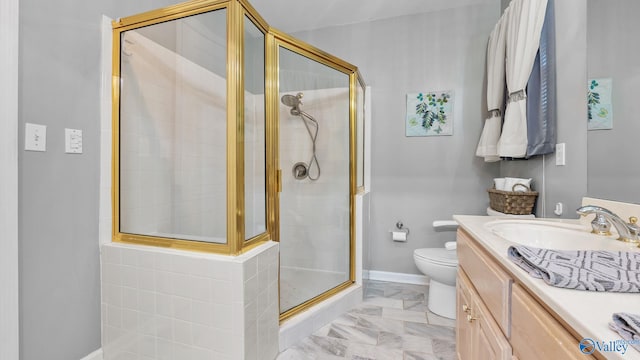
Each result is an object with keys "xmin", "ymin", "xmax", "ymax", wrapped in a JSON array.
[{"xmin": 453, "ymin": 215, "xmax": 640, "ymax": 360}]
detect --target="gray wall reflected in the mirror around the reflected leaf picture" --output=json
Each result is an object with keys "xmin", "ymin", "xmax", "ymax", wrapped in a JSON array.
[{"xmin": 587, "ymin": 0, "xmax": 640, "ymax": 204}]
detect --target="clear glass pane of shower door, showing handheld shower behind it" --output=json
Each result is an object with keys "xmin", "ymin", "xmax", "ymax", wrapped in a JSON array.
[{"xmin": 278, "ymin": 46, "xmax": 351, "ymax": 314}]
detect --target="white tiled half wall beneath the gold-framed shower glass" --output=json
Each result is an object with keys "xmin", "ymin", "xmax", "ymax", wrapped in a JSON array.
[{"xmin": 101, "ymin": 242, "xmax": 279, "ymax": 360}]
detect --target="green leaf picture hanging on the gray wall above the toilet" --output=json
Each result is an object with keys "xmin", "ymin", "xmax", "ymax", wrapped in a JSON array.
[{"xmin": 406, "ymin": 91, "xmax": 453, "ymax": 136}]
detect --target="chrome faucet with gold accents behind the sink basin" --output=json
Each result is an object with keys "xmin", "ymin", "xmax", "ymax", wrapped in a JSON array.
[{"xmin": 576, "ymin": 205, "xmax": 640, "ymax": 243}]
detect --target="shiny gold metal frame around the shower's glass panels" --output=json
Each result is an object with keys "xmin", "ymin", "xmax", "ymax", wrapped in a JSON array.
[{"xmin": 112, "ymin": 0, "xmax": 365, "ymax": 320}]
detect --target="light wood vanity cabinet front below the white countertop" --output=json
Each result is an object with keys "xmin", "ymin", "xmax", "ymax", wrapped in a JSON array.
[{"xmin": 456, "ymin": 229, "xmax": 594, "ymax": 360}]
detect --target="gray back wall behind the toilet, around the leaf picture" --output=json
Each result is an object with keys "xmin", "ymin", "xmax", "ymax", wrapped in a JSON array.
[{"xmin": 294, "ymin": 1, "xmax": 500, "ymax": 274}]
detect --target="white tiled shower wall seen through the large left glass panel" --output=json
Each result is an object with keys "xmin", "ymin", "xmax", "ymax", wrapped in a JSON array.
[{"xmin": 120, "ymin": 32, "xmax": 227, "ymax": 242}]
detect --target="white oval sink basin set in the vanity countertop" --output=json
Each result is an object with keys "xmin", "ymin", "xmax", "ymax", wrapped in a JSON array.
[{"xmin": 485, "ymin": 219, "xmax": 635, "ymax": 251}]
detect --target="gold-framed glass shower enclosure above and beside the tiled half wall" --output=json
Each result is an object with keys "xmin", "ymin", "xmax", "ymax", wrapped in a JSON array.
[{"xmin": 113, "ymin": 0, "xmax": 364, "ymax": 320}]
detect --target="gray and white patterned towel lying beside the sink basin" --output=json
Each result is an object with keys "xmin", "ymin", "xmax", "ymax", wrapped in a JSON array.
[{"xmin": 508, "ymin": 246, "xmax": 640, "ymax": 293}]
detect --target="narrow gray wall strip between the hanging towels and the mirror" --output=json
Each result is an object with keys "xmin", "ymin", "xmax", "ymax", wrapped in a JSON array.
[{"xmin": 500, "ymin": 0, "xmax": 587, "ymax": 218}]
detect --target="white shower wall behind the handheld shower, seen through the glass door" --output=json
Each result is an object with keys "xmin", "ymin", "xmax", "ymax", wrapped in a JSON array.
[{"xmin": 280, "ymin": 88, "xmax": 349, "ymax": 273}]
